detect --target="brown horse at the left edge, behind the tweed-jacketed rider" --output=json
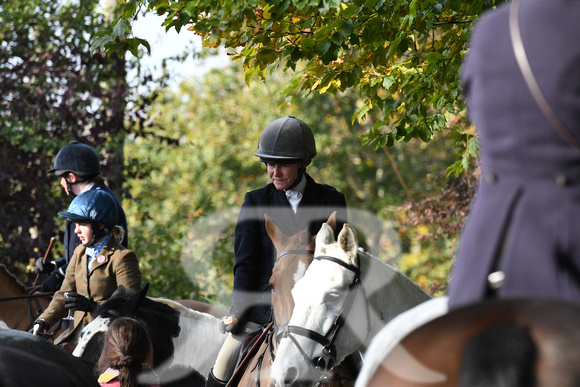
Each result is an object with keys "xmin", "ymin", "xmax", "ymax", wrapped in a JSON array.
[{"xmin": 0, "ymin": 265, "xmax": 60, "ymax": 337}]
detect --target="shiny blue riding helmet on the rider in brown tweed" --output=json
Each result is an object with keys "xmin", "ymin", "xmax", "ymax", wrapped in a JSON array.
[{"xmin": 58, "ymin": 189, "xmax": 119, "ymax": 230}]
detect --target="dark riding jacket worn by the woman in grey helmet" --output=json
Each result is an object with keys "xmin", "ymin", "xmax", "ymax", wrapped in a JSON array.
[{"xmin": 232, "ymin": 174, "xmax": 347, "ymax": 324}]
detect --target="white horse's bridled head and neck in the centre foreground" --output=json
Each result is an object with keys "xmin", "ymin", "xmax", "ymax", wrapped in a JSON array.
[{"xmin": 272, "ymin": 224, "xmax": 431, "ymax": 386}]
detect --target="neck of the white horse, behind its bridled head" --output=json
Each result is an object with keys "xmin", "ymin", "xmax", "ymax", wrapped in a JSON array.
[{"xmin": 359, "ymin": 251, "xmax": 431, "ymax": 344}]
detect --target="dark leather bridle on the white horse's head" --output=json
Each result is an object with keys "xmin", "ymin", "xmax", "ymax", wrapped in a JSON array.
[{"xmin": 277, "ymin": 255, "xmax": 370, "ymax": 372}]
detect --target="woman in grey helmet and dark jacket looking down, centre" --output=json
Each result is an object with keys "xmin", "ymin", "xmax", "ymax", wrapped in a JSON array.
[{"xmin": 206, "ymin": 116, "xmax": 347, "ymax": 386}]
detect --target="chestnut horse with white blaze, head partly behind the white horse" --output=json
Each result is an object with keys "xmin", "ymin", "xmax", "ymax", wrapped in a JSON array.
[{"xmin": 236, "ymin": 213, "xmax": 355, "ymax": 387}]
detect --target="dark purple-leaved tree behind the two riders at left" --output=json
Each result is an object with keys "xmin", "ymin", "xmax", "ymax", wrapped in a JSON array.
[{"xmin": 0, "ymin": 0, "xmax": 133, "ymax": 279}]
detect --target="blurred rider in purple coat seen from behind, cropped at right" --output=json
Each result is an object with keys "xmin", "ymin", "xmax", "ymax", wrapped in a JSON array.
[{"xmin": 449, "ymin": 0, "xmax": 580, "ymax": 308}]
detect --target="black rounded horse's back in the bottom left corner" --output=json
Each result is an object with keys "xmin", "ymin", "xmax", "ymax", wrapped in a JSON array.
[{"xmin": 0, "ymin": 330, "xmax": 99, "ymax": 387}]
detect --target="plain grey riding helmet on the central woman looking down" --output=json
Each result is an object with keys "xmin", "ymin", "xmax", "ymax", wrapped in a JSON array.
[{"xmin": 254, "ymin": 116, "xmax": 316, "ymax": 163}]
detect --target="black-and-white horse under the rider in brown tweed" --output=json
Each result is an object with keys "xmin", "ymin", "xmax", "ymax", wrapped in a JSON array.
[{"xmin": 73, "ymin": 287, "xmax": 226, "ymax": 385}]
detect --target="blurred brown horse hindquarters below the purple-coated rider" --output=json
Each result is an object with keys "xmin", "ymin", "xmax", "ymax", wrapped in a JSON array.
[{"xmin": 368, "ymin": 299, "xmax": 580, "ymax": 387}]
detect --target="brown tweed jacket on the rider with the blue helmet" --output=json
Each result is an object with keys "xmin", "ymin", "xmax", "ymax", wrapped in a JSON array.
[{"xmin": 39, "ymin": 237, "xmax": 142, "ymax": 344}]
